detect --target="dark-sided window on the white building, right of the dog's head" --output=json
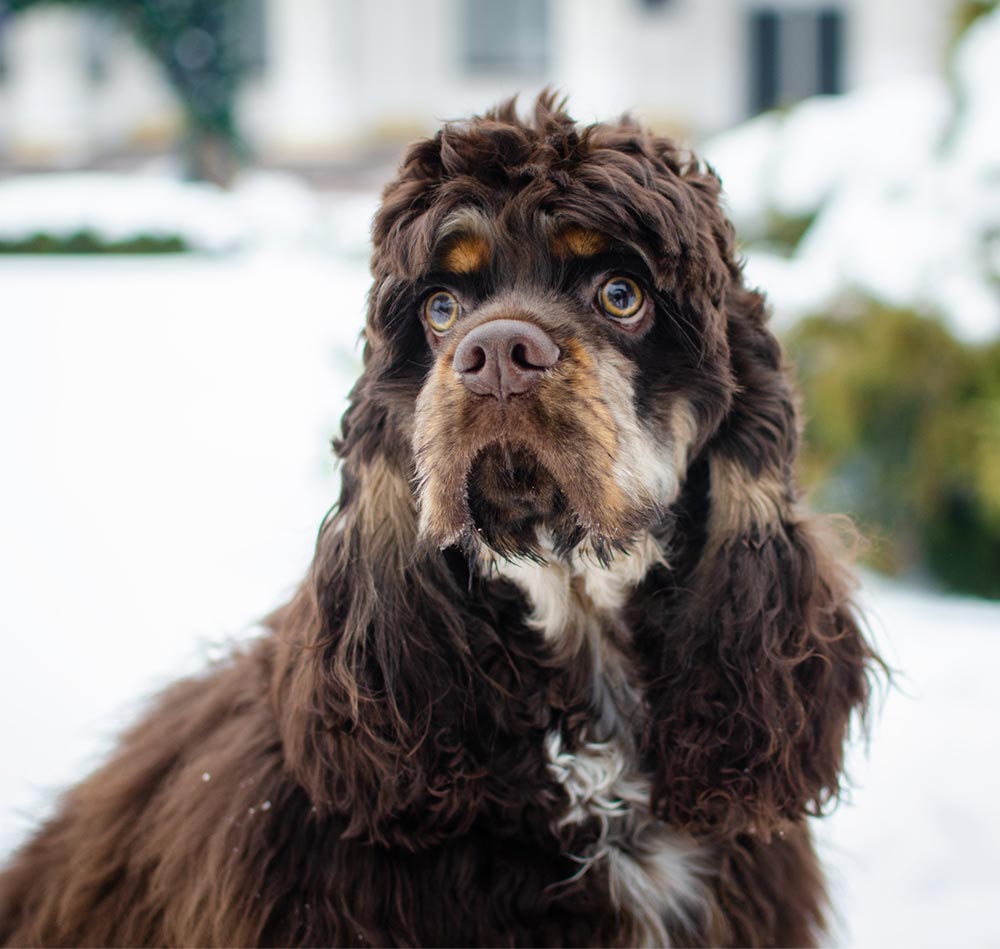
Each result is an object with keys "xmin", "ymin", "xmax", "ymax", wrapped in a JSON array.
[{"xmin": 749, "ymin": 7, "xmax": 844, "ymax": 113}]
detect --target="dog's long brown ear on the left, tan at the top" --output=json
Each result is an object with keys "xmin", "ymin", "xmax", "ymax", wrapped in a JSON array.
[{"xmin": 272, "ymin": 377, "xmax": 492, "ymax": 849}]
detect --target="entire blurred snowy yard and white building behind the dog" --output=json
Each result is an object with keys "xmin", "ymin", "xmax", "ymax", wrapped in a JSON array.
[{"xmin": 0, "ymin": 0, "xmax": 1000, "ymax": 946}]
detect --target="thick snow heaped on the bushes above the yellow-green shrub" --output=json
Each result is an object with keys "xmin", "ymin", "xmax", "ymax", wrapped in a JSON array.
[{"xmin": 702, "ymin": 8, "xmax": 1000, "ymax": 342}]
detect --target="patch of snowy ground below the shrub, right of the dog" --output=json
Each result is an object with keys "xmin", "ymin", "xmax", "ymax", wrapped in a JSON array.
[{"xmin": 816, "ymin": 576, "xmax": 1000, "ymax": 947}]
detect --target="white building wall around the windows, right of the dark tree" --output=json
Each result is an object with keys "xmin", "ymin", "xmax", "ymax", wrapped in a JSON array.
[{"xmin": 236, "ymin": 0, "xmax": 954, "ymax": 151}]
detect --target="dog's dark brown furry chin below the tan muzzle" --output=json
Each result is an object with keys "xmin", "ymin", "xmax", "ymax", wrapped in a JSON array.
[{"xmin": 465, "ymin": 443, "xmax": 585, "ymax": 559}]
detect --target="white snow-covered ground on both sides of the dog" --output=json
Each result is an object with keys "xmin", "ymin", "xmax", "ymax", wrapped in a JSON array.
[{"xmin": 0, "ymin": 235, "xmax": 1000, "ymax": 946}]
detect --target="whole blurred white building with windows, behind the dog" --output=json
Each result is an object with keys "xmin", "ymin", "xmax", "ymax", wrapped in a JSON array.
[{"xmin": 0, "ymin": 0, "xmax": 955, "ymax": 165}]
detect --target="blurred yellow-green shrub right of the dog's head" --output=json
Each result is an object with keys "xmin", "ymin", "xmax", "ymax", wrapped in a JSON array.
[{"xmin": 786, "ymin": 303, "xmax": 1000, "ymax": 597}]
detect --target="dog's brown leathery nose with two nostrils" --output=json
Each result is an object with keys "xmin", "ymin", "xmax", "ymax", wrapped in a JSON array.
[{"xmin": 454, "ymin": 320, "xmax": 559, "ymax": 399}]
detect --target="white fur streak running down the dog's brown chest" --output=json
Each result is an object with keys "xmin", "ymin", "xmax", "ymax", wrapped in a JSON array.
[{"xmin": 488, "ymin": 538, "xmax": 707, "ymax": 945}]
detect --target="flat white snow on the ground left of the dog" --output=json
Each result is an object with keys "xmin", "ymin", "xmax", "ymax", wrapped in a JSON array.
[{"xmin": 0, "ymin": 243, "xmax": 367, "ymax": 849}]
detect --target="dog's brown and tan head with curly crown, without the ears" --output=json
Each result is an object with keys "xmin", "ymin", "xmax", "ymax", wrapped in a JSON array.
[{"xmin": 365, "ymin": 99, "xmax": 738, "ymax": 559}]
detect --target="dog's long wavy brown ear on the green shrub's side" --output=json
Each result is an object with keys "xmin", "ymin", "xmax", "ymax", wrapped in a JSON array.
[{"xmin": 645, "ymin": 280, "xmax": 874, "ymax": 835}]
